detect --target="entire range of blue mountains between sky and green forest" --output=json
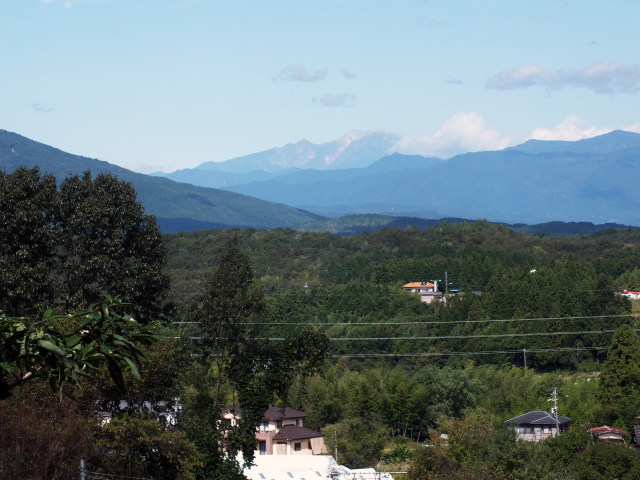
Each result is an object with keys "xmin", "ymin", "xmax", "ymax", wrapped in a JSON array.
[{"xmin": 0, "ymin": 130, "xmax": 640, "ymax": 233}]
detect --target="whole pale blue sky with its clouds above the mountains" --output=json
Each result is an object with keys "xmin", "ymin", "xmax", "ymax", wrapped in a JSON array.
[{"xmin": 0, "ymin": 0, "xmax": 640, "ymax": 173}]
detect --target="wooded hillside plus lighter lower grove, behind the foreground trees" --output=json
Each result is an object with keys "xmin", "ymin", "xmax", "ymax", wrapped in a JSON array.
[{"xmin": 160, "ymin": 221, "xmax": 640, "ymax": 479}]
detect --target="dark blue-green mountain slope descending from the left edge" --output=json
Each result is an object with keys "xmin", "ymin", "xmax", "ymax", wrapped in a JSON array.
[{"xmin": 0, "ymin": 130, "xmax": 318, "ymax": 231}]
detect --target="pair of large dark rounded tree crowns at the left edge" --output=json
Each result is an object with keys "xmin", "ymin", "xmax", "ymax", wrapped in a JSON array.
[{"xmin": 0, "ymin": 168, "xmax": 169, "ymax": 322}]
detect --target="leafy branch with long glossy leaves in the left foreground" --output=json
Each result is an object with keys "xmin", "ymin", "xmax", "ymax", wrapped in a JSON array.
[{"xmin": 0, "ymin": 296, "xmax": 159, "ymax": 399}]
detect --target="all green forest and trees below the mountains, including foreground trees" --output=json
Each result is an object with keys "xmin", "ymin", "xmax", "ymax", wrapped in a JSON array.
[{"xmin": 0, "ymin": 169, "xmax": 640, "ymax": 480}]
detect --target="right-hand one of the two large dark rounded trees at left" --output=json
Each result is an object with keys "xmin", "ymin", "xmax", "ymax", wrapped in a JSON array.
[{"xmin": 59, "ymin": 173, "xmax": 169, "ymax": 321}]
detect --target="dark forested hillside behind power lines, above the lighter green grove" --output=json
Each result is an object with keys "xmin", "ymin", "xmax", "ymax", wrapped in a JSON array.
[{"xmin": 165, "ymin": 222, "xmax": 640, "ymax": 370}]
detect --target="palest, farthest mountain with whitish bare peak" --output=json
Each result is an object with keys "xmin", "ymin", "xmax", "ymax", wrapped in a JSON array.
[{"xmin": 153, "ymin": 131, "xmax": 398, "ymax": 188}]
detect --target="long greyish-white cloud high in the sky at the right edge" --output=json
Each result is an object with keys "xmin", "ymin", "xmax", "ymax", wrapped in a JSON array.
[{"xmin": 486, "ymin": 61, "xmax": 640, "ymax": 94}]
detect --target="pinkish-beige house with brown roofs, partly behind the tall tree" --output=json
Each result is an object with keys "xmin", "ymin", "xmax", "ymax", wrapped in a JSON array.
[{"xmin": 222, "ymin": 405, "xmax": 327, "ymax": 456}]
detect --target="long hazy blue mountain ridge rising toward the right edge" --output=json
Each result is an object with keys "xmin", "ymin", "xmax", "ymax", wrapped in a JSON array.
[{"xmin": 222, "ymin": 131, "xmax": 640, "ymax": 225}]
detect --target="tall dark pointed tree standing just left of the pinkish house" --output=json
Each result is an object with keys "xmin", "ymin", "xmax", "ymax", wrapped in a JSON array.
[{"xmin": 183, "ymin": 235, "xmax": 329, "ymax": 479}]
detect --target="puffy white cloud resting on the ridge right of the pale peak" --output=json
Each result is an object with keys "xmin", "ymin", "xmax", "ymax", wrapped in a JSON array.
[{"xmin": 396, "ymin": 113, "xmax": 513, "ymax": 158}]
